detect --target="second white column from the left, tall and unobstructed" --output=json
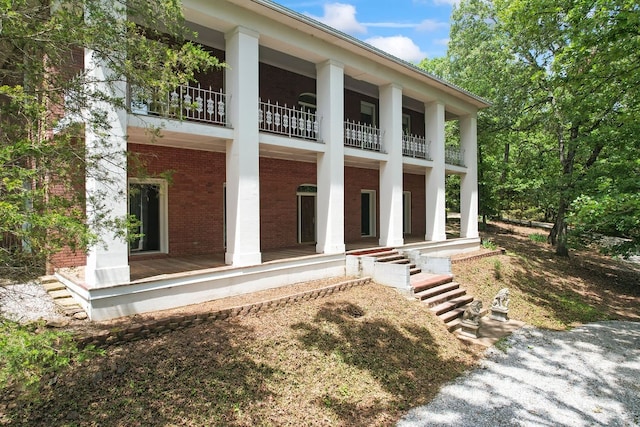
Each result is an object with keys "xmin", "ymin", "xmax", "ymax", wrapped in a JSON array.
[{"xmin": 225, "ymin": 27, "xmax": 262, "ymax": 266}]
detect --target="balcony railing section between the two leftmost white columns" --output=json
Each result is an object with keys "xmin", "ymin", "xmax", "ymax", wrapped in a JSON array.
[{"xmin": 131, "ymin": 86, "xmax": 230, "ymax": 126}]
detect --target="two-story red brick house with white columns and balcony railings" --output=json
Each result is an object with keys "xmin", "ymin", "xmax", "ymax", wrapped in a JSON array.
[{"xmin": 53, "ymin": 0, "xmax": 487, "ymax": 319}]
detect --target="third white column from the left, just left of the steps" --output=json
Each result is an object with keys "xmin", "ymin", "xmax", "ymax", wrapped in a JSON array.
[{"xmin": 316, "ymin": 60, "xmax": 345, "ymax": 254}]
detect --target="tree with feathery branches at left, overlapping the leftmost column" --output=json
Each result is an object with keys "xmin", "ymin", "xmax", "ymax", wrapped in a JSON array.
[{"xmin": 0, "ymin": 0, "xmax": 221, "ymax": 277}]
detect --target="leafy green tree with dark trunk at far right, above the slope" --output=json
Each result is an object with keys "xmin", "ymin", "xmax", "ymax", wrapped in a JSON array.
[{"xmin": 496, "ymin": 0, "xmax": 640, "ymax": 255}]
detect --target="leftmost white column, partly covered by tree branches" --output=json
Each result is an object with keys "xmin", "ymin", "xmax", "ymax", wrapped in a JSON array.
[{"xmin": 84, "ymin": 50, "xmax": 130, "ymax": 288}]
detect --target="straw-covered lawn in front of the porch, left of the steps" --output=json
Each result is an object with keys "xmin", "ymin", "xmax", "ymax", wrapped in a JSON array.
[{"xmin": 3, "ymin": 284, "xmax": 480, "ymax": 426}]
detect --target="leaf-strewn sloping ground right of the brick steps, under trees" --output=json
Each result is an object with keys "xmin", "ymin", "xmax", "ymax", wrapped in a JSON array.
[{"xmin": 453, "ymin": 223, "xmax": 640, "ymax": 330}]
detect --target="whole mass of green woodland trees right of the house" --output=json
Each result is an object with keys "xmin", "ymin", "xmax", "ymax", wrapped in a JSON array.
[{"xmin": 430, "ymin": 0, "xmax": 640, "ymax": 255}]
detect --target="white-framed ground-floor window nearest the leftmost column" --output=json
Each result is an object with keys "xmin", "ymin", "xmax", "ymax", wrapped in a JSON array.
[{"xmin": 129, "ymin": 179, "xmax": 168, "ymax": 253}]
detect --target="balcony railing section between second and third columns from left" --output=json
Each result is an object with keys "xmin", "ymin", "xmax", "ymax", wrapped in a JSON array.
[{"xmin": 258, "ymin": 101, "xmax": 319, "ymax": 141}]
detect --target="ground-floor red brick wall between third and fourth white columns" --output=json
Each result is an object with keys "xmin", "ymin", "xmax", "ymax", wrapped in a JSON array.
[{"xmin": 344, "ymin": 167, "xmax": 380, "ymax": 242}]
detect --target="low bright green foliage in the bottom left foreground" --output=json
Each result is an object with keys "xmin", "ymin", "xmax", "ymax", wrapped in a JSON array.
[{"xmin": 0, "ymin": 319, "xmax": 99, "ymax": 394}]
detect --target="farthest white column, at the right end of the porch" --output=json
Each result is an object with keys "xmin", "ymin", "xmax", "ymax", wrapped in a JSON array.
[{"xmin": 460, "ymin": 113, "xmax": 478, "ymax": 238}]
